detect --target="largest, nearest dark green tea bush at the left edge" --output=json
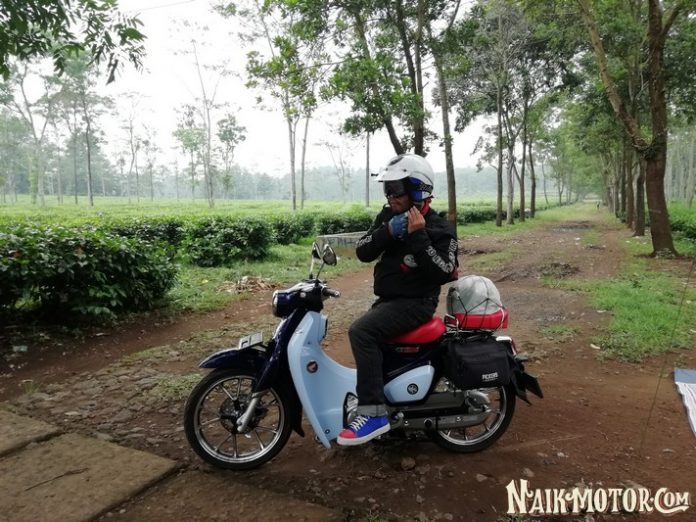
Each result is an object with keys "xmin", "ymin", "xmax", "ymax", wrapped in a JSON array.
[{"xmin": 0, "ymin": 225, "xmax": 176, "ymax": 319}]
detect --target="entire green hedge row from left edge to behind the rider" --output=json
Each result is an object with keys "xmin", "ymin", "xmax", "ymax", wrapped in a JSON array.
[{"xmin": 0, "ymin": 207, "xmax": 372, "ymax": 320}]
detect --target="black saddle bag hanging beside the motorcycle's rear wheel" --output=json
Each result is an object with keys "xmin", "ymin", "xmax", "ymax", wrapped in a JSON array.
[{"xmin": 444, "ymin": 337, "xmax": 512, "ymax": 390}]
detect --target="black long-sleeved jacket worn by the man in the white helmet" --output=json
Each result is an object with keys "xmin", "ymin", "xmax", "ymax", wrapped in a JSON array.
[{"xmin": 355, "ymin": 205, "xmax": 457, "ymax": 299}]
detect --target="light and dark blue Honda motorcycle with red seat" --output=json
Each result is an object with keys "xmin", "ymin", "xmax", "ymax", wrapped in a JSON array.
[{"xmin": 184, "ymin": 243, "xmax": 543, "ymax": 470}]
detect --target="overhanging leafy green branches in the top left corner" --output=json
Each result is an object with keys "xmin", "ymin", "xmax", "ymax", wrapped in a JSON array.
[{"xmin": 0, "ymin": 0, "xmax": 145, "ymax": 82}]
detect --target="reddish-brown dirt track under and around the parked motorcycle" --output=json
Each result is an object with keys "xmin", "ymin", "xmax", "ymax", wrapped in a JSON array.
[{"xmin": 1, "ymin": 208, "xmax": 696, "ymax": 521}]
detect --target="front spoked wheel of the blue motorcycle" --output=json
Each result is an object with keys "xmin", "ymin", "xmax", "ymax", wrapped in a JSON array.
[{"xmin": 184, "ymin": 370, "xmax": 291, "ymax": 470}]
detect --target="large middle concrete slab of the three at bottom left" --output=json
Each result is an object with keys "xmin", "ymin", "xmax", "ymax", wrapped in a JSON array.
[{"xmin": 0, "ymin": 426, "xmax": 177, "ymax": 522}]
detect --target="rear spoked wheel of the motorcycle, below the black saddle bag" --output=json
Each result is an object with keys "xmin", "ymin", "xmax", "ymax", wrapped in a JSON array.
[{"xmin": 430, "ymin": 385, "xmax": 517, "ymax": 453}]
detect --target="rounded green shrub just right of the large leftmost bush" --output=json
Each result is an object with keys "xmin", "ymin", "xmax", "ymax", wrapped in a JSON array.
[{"xmin": 184, "ymin": 217, "xmax": 273, "ymax": 266}]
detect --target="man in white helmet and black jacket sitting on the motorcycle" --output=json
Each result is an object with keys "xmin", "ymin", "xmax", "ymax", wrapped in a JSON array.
[{"xmin": 337, "ymin": 154, "xmax": 457, "ymax": 446}]
